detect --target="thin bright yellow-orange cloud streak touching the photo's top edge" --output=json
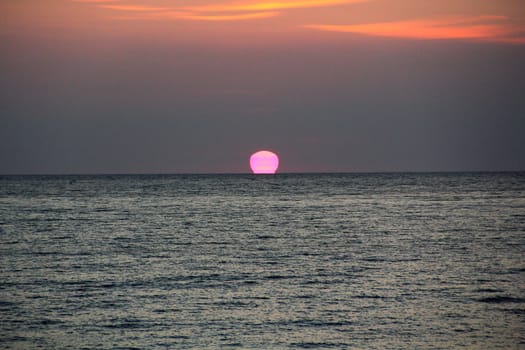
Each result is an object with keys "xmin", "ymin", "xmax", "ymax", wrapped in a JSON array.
[{"xmin": 187, "ymin": 0, "xmax": 368, "ymax": 12}]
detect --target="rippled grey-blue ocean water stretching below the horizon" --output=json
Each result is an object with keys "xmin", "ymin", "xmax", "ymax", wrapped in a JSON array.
[{"xmin": 0, "ymin": 173, "xmax": 525, "ymax": 349}]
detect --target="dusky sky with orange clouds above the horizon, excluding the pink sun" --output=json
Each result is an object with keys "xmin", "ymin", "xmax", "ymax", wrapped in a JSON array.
[{"xmin": 0, "ymin": 0, "xmax": 525, "ymax": 174}]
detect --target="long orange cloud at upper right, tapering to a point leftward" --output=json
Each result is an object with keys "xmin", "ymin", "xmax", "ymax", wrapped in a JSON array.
[{"xmin": 305, "ymin": 16, "xmax": 524, "ymax": 43}]
